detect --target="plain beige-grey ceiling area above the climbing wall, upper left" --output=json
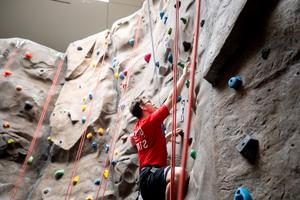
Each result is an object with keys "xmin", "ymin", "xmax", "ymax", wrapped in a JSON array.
[{"xmin": 0, "ymin": 0, "xmax": 143, "ymax": 52}]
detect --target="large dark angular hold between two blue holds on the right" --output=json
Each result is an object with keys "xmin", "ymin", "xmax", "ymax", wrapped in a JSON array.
[{"xmin": 235, "ymin": 135, "xmax": 258, "ymax": 164}]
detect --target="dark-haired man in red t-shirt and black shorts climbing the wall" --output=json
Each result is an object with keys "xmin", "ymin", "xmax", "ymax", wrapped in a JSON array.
[{"xmin": 130, "ymin": 63, "xmax": 189, "ymax": 200}]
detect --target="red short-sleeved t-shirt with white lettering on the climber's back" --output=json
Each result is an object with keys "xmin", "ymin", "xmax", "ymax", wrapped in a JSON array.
[{"xmin": 132, "ymin": 105, "xmax": 170, "ymax": 169}]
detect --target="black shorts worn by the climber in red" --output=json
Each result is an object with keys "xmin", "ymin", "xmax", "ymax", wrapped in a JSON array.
[{"xmin": 140, "ymin": 166, "xmax": 170, "ymax": 200}]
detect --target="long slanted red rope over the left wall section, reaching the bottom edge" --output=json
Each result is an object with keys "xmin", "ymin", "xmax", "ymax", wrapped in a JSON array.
[{"xmin": 10, "ymin": 58, "xmax": 64, "ymax": 200}]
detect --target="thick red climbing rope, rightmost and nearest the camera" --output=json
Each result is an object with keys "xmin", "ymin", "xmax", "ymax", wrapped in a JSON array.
[{"xmin": 178, "ymin": 0, "xmax": 201, "ymax": 200}]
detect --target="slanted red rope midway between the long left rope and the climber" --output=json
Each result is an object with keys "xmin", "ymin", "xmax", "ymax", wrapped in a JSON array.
[{"xmin": 65, "ymin": 41, "xmax": 108, "ymax": 200}]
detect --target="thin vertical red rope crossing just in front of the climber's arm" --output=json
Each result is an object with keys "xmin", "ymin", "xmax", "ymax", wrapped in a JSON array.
[{"xmin": 170, "ymin": 0, "xmax": 179, "ymax": 199}]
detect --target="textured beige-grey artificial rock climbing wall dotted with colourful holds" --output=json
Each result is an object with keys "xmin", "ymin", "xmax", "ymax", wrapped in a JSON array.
[{"xmin": 0, "ymin": 0, "xmax": 300, "ymax": 200}]
